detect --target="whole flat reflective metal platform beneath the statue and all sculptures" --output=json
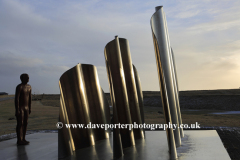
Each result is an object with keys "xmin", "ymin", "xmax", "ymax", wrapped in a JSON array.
[{"xmin": 0, "ymin": 130, "xmax": 230, "ymax": 160}]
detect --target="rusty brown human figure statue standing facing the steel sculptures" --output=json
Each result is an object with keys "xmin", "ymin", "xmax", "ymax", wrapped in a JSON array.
[{"xmin": 15, "ymin": 73, "xmax": 32, "ymax": 145}]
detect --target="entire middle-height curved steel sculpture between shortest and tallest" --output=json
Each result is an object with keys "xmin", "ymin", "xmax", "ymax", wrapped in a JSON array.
[{"xmin": 104, "ymin": 36, "xmax": 144, "ymax": 158}]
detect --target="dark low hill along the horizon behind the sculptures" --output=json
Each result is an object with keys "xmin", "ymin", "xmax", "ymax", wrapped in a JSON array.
[{"xmin": 32, "ymin": 89, "xmax": 240, "ymax": 111}]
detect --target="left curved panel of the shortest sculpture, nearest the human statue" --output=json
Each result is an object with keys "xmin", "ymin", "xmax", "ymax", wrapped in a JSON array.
[{"xmin": 59, "ymin": 64, "xmax": 95, "ymax": 152}]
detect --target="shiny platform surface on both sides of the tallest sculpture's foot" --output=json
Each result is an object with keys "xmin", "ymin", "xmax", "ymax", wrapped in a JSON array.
[{"xmin": 119, "ymin": 130, "xmax": 230, "ymax": 160}]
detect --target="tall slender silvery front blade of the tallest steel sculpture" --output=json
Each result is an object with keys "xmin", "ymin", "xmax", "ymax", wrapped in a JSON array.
[{"xmin": 150, "ymin": 6, "xmax": 181, "ymax": 159}]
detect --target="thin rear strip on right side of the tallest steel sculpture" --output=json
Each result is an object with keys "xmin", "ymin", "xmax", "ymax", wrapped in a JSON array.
[{"xmin": 170, "ymin": 48, "xmax": 184, "ymax": 138}]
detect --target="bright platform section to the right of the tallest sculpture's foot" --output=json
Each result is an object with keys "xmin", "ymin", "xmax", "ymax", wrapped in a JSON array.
[{"xmin": 177, "ymin": 130, "xmax": 231, "ymax": 160}]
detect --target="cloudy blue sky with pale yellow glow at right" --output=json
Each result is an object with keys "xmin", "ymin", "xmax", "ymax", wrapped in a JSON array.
[{"xmin": 0, "ymin": 0, "xmax": 240, "ymax": 94}]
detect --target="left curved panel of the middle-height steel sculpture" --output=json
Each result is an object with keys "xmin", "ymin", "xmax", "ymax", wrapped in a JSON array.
[{"xmin": 104, "ymin": 36, "xmax": 135, "ymax": 152}]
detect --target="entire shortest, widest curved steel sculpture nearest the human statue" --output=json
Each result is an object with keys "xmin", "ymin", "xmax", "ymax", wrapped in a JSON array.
[{"xmin": 58, "ymin": 64, "xmax": 109, "ymax": 158}]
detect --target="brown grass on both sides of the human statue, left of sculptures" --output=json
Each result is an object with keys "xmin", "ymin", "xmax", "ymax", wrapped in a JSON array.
[{"xmin": 0, "ymin": 97, "xmax": 59, "ymax": 135}]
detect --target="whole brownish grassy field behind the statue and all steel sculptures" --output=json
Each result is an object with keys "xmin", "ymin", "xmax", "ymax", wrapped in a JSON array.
[{"xmin": 0, "ymin": 95, "xmax": 240, "ymax": 135}]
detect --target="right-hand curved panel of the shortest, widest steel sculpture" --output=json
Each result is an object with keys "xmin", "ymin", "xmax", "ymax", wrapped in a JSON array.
[{"xmin": 81, "ymin": 64, "xmax": 110, "ymax": 141}]
